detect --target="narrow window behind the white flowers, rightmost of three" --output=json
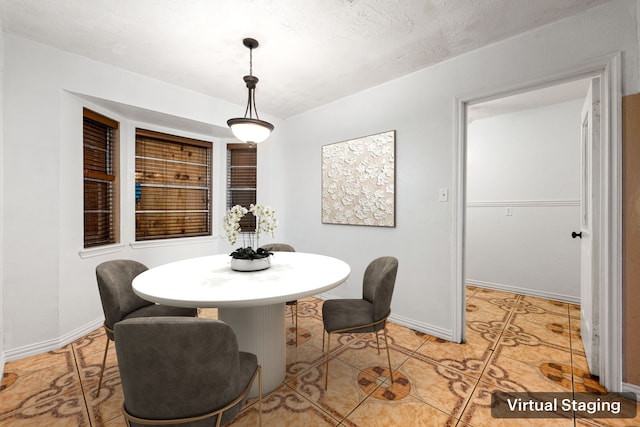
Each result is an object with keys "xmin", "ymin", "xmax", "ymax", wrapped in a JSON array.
[{"xmin": 227, "ymin": 144, "xmax": 257, "ymax": 230}]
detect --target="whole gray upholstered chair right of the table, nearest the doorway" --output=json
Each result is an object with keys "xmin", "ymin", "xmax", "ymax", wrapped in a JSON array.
[{"xmin": 322, "ymin": 256, "xmax": 398, "ymax": 390}]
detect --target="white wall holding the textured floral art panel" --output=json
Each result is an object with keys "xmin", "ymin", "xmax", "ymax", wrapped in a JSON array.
[{"xmin": 284, "ymin": 1, "xmax": 640, "ymax": 338}]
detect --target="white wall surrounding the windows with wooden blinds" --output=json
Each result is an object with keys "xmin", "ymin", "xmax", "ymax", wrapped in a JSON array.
[{"xmin": 2, "ymin": 35, "xmax": 280, "ymax": 360}]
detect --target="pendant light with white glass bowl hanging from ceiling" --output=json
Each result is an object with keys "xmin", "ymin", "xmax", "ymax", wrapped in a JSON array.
[{"xmin": 227, "ymin": 38, "xmax": 273, "ymax": 147}]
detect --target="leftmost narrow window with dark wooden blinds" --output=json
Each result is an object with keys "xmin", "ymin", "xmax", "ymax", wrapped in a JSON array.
[{"xmin": 82, "ymin": 108, "xmax": 118, "ymax": 248}]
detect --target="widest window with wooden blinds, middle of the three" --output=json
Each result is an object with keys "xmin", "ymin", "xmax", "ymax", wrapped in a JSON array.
[{"xmin": 135, "ymin": 129, "xmax": 211, "ymax": 241}]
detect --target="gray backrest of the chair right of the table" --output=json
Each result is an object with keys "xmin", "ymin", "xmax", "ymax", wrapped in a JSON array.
[{"xmin": 362, "ymin": 256, "xmax": 398, "ymax": 322}]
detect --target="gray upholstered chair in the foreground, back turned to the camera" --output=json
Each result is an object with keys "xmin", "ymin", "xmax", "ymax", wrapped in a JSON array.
[{"xmin": 114, "ymin": 317, "xmax": 262, "ymax": 427}]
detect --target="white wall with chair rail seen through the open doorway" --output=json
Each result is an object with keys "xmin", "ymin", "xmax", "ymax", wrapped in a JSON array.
[{"xmin": 465, "ymin": 100, "xmax": 586, "ymax": 304}]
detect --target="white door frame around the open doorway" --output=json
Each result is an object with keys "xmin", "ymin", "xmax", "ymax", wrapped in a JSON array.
[{"xmin": 452, "ymin": 52, "xmax": 623, "ymax": 392}]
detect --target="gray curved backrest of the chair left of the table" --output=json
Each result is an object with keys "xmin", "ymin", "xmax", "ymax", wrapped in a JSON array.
[{"xmin": 96, "ymin": 259, "xmax": 153, "ymax": 329}]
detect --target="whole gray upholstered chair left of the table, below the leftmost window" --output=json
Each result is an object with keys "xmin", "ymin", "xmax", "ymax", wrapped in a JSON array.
[{"xmin": 96, "ymin": 259, "xmax": 198, "ymax": 396}]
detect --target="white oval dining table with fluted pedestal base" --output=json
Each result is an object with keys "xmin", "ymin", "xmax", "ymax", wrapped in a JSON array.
[{"xmin": 133, "ymin": 252, "xmax": 351, "ymax": 395}]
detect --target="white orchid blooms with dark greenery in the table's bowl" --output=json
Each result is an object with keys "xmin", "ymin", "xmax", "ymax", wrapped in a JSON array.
[{"xmin": 224, "ymin": 204, "xmax": 278, "ymax": 259}]
